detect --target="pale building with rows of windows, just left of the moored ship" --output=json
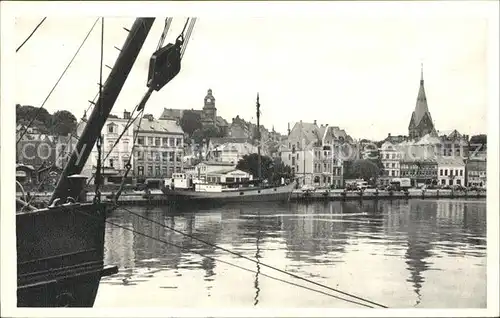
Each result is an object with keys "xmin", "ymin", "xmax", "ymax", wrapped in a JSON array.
[{"xmin": 133, "ymin": 116, "xmax": 184, "ymax": 182}]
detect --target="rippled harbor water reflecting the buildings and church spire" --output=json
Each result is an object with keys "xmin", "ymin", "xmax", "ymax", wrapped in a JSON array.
[{"xmin": 95, "ymin": 199, "xmax": 487, "ymax": 308}]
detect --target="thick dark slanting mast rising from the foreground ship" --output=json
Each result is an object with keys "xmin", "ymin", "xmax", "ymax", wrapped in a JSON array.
[{"xmin": 50, "ymin": 18, "xmax": 155, "ymax": 202}]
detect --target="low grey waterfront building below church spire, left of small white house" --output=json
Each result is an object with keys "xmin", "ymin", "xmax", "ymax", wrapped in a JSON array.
[{"xmin": 400, "ymin": 158, "xmax": 438, "ymax": 187}]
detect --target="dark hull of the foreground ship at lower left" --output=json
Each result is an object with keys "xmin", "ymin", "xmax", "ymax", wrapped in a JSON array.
[{"xmin": 16, "ymin": 204, "xmax": 117, "ymax": 307}]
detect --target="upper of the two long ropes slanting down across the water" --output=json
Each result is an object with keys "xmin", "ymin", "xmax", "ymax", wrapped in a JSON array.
[{"xmin": 120, "ymin": 207, "xmax": 388, "ymax": 308}]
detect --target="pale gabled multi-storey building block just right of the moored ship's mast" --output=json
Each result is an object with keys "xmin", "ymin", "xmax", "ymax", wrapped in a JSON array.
[{"xmin": 281, "ymin": 121, "xmax": 352, "ymax": 187}]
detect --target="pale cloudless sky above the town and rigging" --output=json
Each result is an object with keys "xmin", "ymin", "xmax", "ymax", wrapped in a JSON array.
[{"xmin": 14, "ymin": 3, "xmax": 488, "ymax": 140}]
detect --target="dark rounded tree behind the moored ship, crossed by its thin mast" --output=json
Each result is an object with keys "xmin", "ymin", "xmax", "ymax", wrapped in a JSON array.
[{"xmin": 236, "ymin": 153, "xmax": 293, "ymax": 183}]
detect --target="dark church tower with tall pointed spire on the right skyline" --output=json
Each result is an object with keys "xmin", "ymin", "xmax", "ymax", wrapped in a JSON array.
[{"xmin": 408, "ymin": 66, "xmax": 436, "ymax": 139}]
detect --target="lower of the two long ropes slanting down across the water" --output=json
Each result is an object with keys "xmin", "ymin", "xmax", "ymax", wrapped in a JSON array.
[{"xmin": 74, "ymin": 207, "xmax": 373, "ymax": 308}]
